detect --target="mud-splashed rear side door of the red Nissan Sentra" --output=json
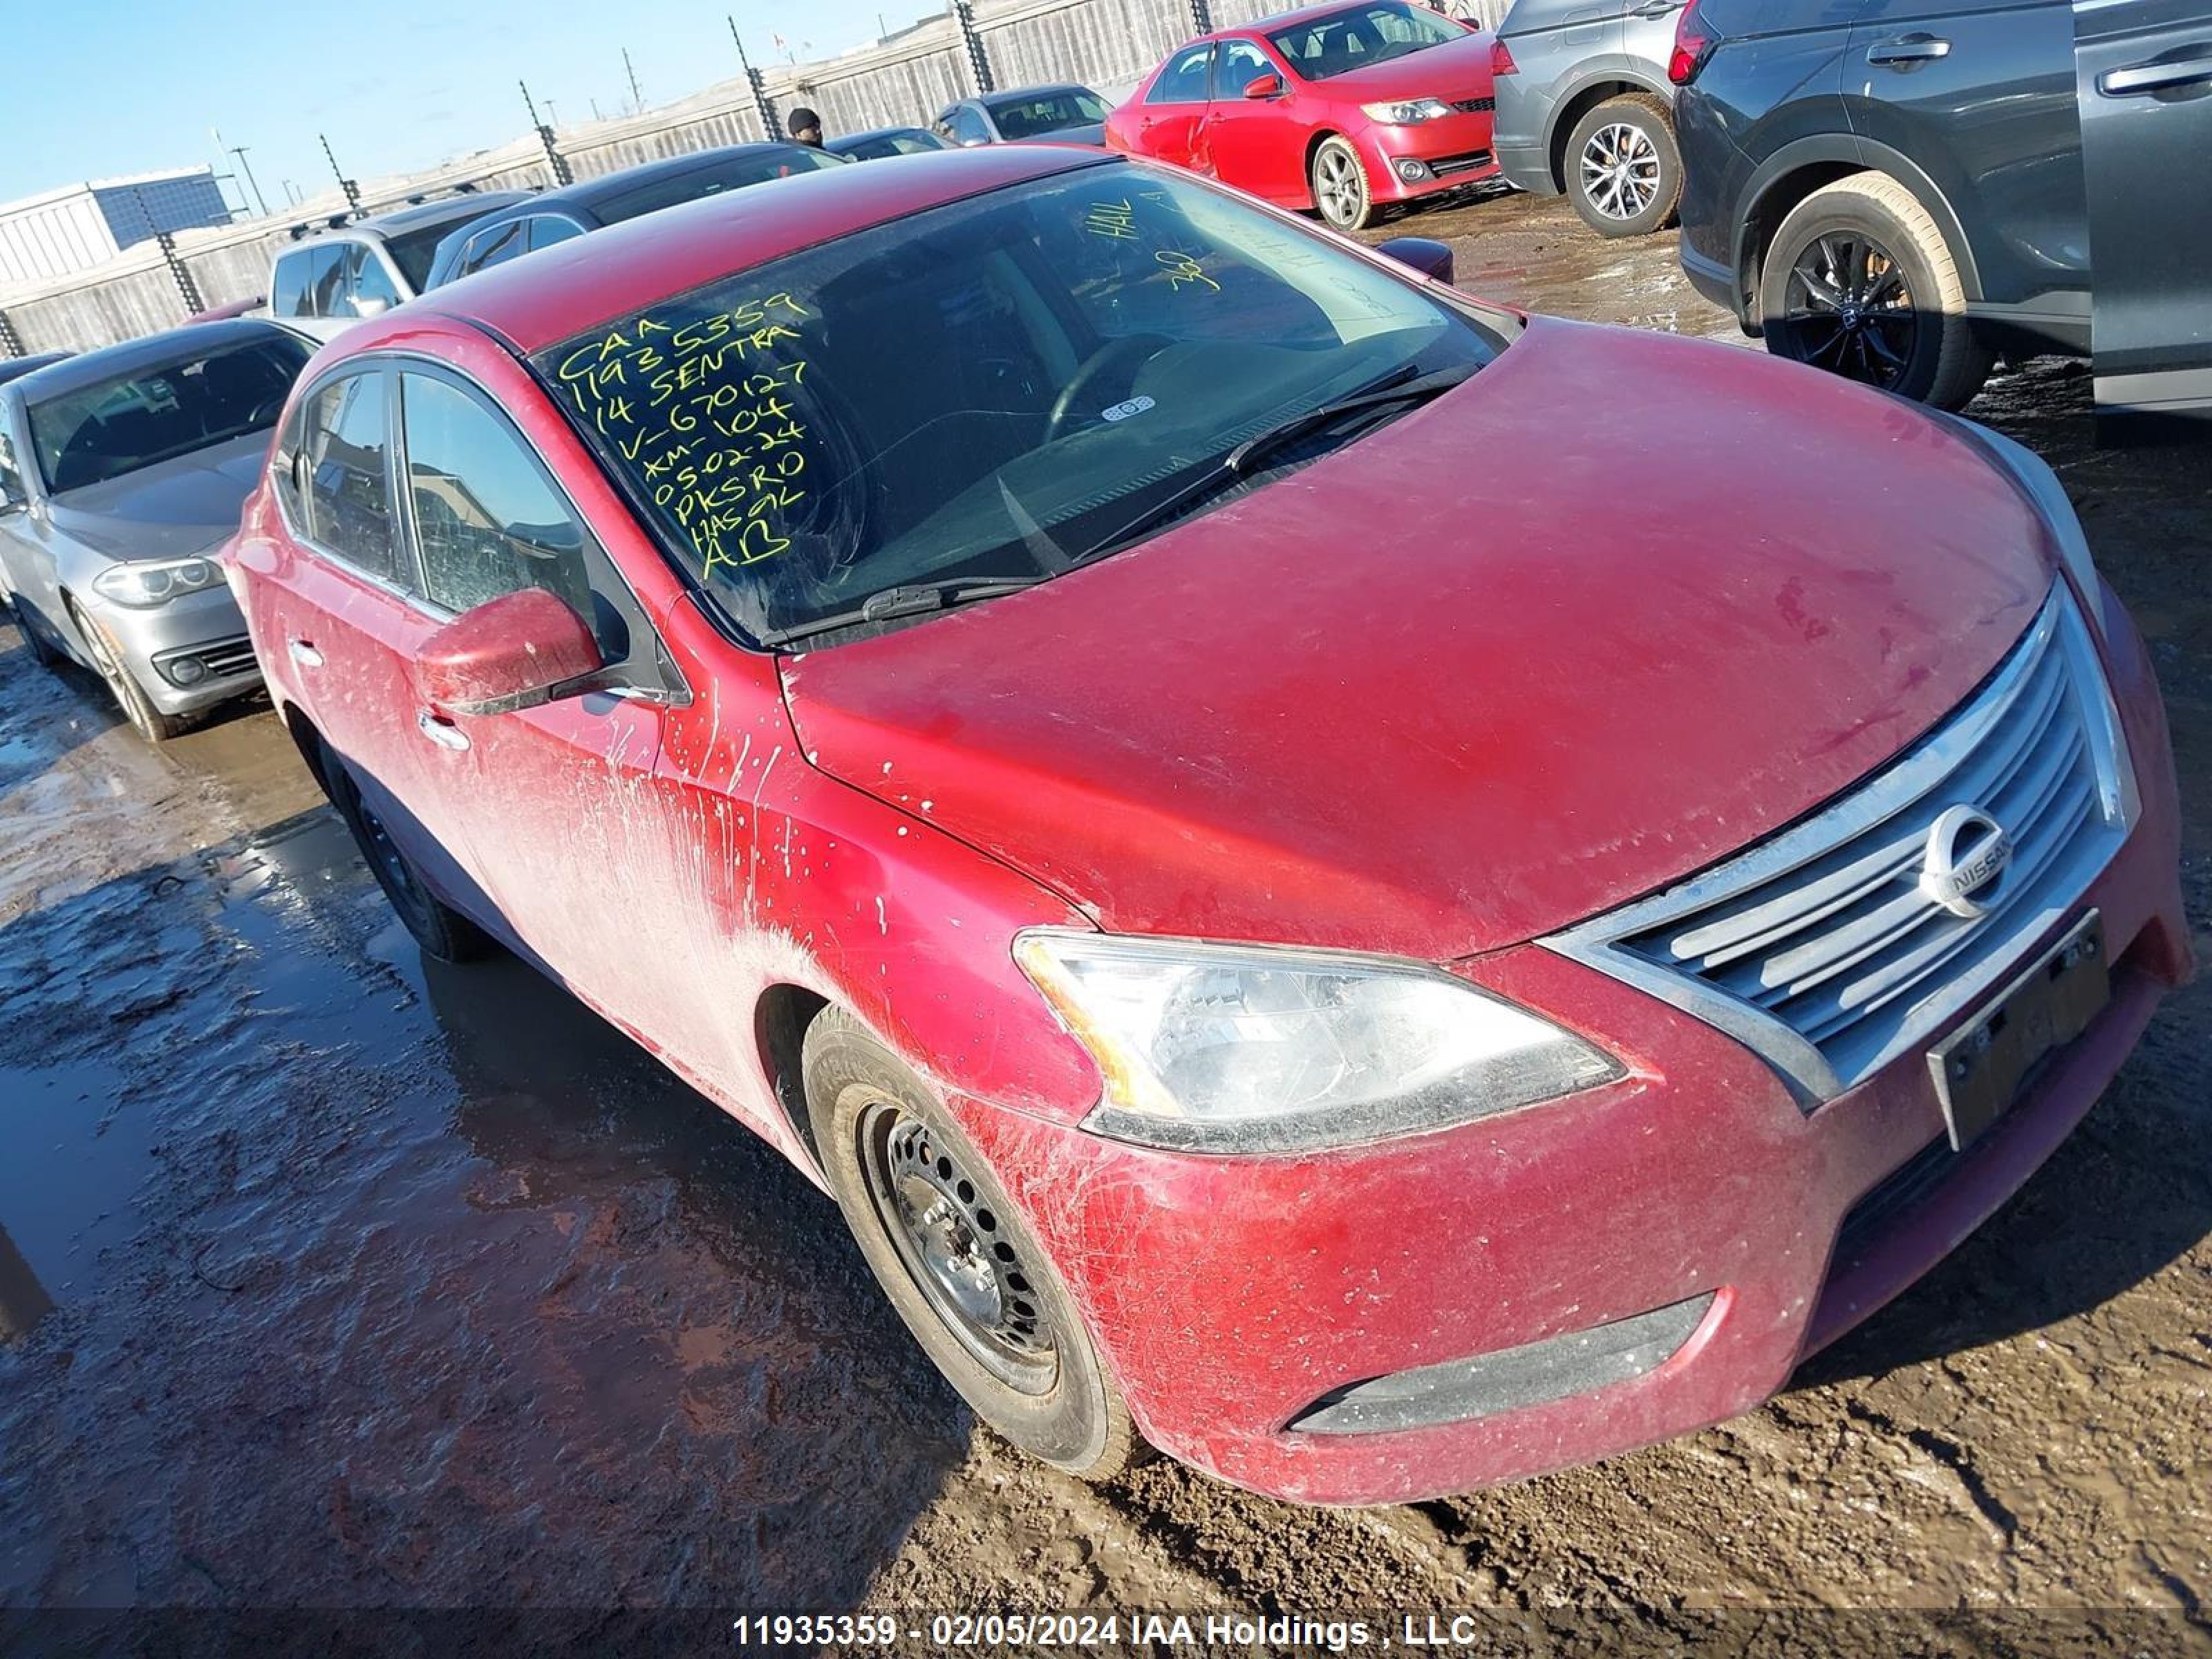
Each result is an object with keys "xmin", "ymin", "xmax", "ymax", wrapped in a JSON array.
[{"xmin": 253, "ymin": 358, "xmax": 480, "ymax": 914}]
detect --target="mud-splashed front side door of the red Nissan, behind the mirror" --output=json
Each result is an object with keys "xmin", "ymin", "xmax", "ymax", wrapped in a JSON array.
[{"xmin": 382, "ymin": 361, "xmax": 699, "ymax": 1047}]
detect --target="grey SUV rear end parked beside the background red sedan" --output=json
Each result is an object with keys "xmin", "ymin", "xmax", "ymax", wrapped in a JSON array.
[{"xmin": 1493, "ymin": 0, "xmax": 1683, "ymax": 236}]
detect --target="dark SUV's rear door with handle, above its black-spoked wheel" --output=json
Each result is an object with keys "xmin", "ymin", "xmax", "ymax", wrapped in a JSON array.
[{"xmin": 1843, "ymin": 0, "xmax": 2088, "ymax": 343}]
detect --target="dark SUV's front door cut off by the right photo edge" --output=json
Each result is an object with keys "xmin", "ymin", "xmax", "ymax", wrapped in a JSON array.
[{"xmin": 2075, "ymin": 0, "xmax": 2212, "ymax": 416}]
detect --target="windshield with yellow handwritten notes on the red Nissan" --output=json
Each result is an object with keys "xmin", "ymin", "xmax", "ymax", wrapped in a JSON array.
[{"xmin": 533, "ymin": 164, "xmax": 1502, "ymax": 639}]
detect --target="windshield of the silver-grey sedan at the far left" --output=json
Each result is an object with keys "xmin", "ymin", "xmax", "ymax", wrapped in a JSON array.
[{"xmin": 29, "ymin": 334, "xmax": 308, "ymax": 496}]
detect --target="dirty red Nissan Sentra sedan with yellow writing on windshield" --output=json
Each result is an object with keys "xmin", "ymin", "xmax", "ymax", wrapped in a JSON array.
[{"xmin": 230, "ymin": 146, "xmax": 2188, "ymax": 1502}]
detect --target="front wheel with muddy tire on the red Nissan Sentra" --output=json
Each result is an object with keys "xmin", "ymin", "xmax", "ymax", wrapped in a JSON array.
[{"xmin": 800, "ymin": 1006, "xmax": 1141, "ymax": 1480}]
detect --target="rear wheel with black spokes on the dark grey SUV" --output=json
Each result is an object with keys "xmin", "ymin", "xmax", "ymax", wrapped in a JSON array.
[{"xmin": 1759, "ymin": 173, "xmax": 1995, "ymax": 409}]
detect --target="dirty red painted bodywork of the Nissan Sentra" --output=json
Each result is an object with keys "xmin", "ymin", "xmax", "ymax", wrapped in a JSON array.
[{"xmin": 216, "ymin": 153, "xmax": 2188, "ymax": 1502}]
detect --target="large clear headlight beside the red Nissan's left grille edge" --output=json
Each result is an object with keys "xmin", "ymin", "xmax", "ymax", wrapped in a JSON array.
[{"xmin": 1015, "ymin": 931, "xmax": 1622, "ymax": 1152}]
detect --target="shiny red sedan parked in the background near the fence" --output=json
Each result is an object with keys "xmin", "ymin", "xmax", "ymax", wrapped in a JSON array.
[{"xmin": 1106, "ymin": 0, "xmax": 1497, "ymax": 230}]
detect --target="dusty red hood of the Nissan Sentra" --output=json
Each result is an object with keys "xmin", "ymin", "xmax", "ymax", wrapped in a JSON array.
[{"xmin": 785, "ymin": 319, "xmax": 2055, "ymax": 960}]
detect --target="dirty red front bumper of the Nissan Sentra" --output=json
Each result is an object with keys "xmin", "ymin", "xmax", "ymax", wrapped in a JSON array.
[{"xmin": 953, "ymin": 601, "xmax": 2188, "ymax": 1504}]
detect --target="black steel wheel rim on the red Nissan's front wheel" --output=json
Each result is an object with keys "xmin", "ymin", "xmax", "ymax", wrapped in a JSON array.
[{"xmin": 861, "ymin": 1102, "xmax": 1060, "ymax": 1396}]
